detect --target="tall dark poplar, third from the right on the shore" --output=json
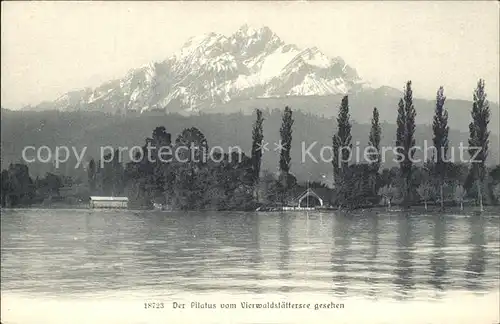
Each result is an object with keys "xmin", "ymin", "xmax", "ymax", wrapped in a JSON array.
[{"xmin": 396, "ymin": 81, "xmax": 416, "ymax": 207}]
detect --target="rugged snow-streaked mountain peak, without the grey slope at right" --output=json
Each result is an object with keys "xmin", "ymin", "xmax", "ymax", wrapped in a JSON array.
[{"xmin": 33, "ymin": 25, "xmax": 362, "ymax": 112}]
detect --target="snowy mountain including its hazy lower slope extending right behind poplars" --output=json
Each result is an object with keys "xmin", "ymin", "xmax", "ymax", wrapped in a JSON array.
[{"xmin": 17, "ymin": 25, "xmax": 500, "ymax": 135}]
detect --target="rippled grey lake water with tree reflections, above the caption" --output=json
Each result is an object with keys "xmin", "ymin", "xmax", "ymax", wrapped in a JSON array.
[{"xmin": 1, "ymin": 210, "xmax": 500, "ymax": 298}]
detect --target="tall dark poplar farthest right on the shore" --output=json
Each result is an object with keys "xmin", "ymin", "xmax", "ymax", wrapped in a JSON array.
[{"xmin": 469, "ymin": 79, "xmax": 490, "ymax": 211}]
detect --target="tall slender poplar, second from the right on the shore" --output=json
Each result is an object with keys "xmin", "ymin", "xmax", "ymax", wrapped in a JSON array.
[{"xmin": 432, "ymin": 87, "xmax": 449, "ymax": 210}]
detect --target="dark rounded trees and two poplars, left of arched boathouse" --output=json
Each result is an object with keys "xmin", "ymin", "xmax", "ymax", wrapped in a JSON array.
[{"xmin": 82, "ymin": 107, "xmax": 296, "ymax": 210}]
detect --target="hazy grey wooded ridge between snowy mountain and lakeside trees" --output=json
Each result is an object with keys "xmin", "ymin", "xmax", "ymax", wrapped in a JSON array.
[{"xmin": 1, "ymin": 109, "xmax": 500, "ymax": 180}]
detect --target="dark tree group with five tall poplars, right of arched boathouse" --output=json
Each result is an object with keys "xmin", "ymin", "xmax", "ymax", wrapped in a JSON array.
[{"xmin": 333, "ymin": 80, "xmax": 500, "ymax": 210}]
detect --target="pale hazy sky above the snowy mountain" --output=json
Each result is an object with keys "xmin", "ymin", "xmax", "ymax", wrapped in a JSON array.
[{"xmin": 1, "ymin": 1, "xmax": 500, "ymax": 108}]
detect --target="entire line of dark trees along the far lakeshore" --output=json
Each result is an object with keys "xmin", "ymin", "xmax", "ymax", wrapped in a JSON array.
[{"xmin": 2, "ymin": 80, "xmax": 500, "ymax": 210}]
